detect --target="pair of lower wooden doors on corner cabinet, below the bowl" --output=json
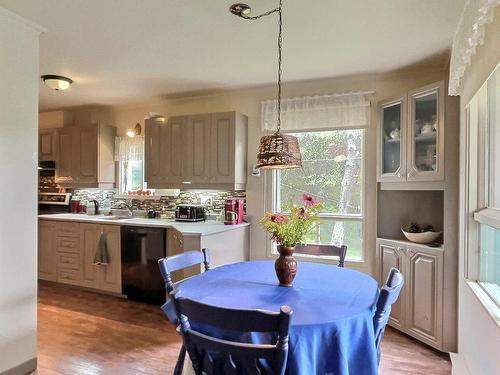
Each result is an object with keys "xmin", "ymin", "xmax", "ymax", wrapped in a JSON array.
[{"xmin": 377, "ymin": 239, "xmax": 445, "ymax": 350}]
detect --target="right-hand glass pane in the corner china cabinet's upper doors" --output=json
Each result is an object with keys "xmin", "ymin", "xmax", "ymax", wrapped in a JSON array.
[{"xmin": 413, "ymin": 92, "xmax": 438, "ymax": 172}]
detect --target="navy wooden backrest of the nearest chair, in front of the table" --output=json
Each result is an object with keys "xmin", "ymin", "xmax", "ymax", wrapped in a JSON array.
[{"xmin": 171, "ymin": 291, "xmax": 292, "ymax": 375}]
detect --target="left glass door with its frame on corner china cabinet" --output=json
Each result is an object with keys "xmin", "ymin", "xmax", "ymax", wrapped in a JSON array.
[{"xmin": 379, "ymin": 98, "xmax": 406, "ymax": 182}]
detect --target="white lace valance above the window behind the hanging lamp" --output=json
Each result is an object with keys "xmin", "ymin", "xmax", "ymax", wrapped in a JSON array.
[{"xmin": 262, "ymin": 93, "xmax": 371, "ymax": 131}]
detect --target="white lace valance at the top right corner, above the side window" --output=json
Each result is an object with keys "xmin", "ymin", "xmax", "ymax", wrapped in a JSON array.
[{"xmin": 448, "ymin": 0, "xmax": 500, "ymax": 95}]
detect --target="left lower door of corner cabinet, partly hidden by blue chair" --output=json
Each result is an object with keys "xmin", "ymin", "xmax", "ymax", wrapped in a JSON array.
[{"xmin": 378, "ymin": 241, "xmax": 406, "ymax": 330}]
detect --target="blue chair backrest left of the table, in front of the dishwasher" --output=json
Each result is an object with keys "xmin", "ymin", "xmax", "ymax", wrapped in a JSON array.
[{"xmin": 158, "ymin": 249, "xmax": 210, "ymax": 293}]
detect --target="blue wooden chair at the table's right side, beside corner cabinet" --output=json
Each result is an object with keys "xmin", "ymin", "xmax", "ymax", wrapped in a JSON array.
[{"xmin": 373, "ymin": 267, "xmax": 404, "ymax": 363}]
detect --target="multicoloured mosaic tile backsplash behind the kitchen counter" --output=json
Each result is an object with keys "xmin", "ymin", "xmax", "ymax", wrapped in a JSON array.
[{"xmin": 73, "ymin": 189, "xmax": 246, "ymax": 216}]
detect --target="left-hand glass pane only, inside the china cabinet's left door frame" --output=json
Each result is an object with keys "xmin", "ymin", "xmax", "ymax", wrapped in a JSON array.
[{"xmin": 381, "ymin": 103, "xmax": 401, "ymax": 173}]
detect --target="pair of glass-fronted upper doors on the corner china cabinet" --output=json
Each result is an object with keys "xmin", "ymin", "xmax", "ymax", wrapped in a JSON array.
[{"xmin": 378, "ymin": 81, "xmax": 445, "ymax": 188}]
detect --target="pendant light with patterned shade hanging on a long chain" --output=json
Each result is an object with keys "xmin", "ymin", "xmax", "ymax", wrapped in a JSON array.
[{"xmin": 229, "ymin": 0, "xmax": 302, "ymax": 169}]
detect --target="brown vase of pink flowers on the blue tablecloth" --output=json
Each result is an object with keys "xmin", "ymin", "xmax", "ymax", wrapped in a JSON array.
[{"xmin": 260, "ymin": 194, "xmax": 322, "ymax": 287}]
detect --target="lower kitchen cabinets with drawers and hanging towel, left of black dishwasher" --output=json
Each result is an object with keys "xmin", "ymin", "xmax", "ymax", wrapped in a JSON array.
[{"xmin": 38, "ymin": 220, "xmax": 121, "ymax": 293}]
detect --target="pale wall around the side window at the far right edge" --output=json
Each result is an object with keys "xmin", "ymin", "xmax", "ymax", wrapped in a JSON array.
[{"xmin": 453, "ymin": 7, "xmax": 500, "ymax": 375}]
